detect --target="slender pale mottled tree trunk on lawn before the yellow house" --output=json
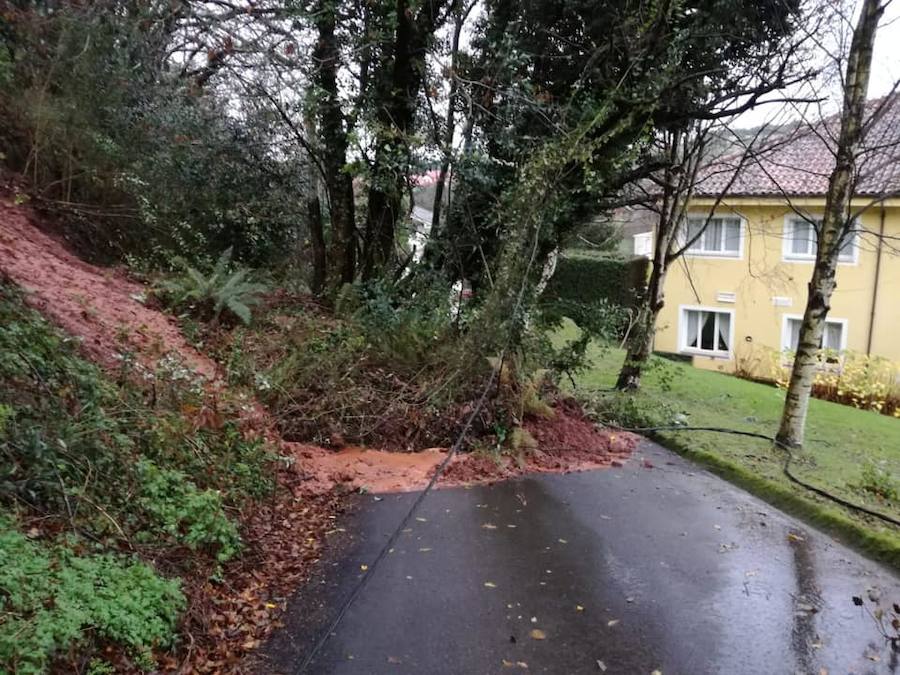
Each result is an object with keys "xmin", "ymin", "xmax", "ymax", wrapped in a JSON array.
[{"xmin": 776, "ymin": 0, "xmax": 884, "ymax": 447}]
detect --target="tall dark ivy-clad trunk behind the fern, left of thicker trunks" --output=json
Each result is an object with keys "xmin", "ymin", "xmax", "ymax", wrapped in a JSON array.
[{"xmin": 312, "ymin": 0, "xmax": 356, "ymax": 287}]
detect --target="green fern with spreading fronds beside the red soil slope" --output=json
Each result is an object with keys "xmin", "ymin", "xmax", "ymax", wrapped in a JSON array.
[{"xmin": 157, "ymin": 248, "xmax": 266, "ymax": 324}]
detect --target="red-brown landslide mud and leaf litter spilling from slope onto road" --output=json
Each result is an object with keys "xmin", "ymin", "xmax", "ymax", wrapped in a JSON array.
[{"xmin": 0, "ymin": 197, "xmax": 635, "ymax": 673}]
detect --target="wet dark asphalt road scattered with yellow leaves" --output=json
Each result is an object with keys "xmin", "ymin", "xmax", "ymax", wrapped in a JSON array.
[{"xmin": 261, "ymin": 442, "xmax": 900, "ymax": 675}]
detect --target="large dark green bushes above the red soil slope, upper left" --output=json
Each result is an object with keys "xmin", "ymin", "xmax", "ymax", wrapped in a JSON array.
[{"xmin": 0, "ymin": 2, "xmax": 307, "ymax": 269}]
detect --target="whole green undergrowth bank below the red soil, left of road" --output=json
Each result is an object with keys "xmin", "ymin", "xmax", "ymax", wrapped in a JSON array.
[{"xmin": 0, "ymin": 285, "xmax": 272, "ymax": 673}]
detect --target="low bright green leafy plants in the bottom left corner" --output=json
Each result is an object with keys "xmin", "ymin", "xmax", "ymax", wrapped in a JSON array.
[{"xmin": 0, "ymin": 519, "xmax": 184, "ymax": 675}]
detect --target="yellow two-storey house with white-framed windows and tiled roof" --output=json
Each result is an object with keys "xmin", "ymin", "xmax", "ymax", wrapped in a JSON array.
[{"xmin": 654, "ymin": 98, "xmax": 900, "ymax": 378}]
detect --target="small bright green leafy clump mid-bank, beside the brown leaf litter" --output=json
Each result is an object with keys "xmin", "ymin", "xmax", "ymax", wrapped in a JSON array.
[{"xmin": 137, "ymin": 460, "xmax": 241, "ymax": 562}]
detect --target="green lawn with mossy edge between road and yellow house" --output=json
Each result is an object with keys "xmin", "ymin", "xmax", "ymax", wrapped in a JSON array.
[{"xmin": 557, "ymin": 324, "xmax": 900, "ymax": 568}]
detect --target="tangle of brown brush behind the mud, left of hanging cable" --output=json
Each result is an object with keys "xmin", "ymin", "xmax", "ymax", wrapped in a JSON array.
[{"xmin": 206, "ymin": 284, "xmax": 492, "ymax": 450}]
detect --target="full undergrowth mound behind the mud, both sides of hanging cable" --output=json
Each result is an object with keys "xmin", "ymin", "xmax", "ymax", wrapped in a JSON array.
[{"xmin": 182, "ymin": 272, "xmax": 618, "ymax": 451}]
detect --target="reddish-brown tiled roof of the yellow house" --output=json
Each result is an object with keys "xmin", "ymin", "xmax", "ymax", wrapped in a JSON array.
[{"xmin": 695, "ymin": 94, "xmax": 900, "ymax": 197}]
